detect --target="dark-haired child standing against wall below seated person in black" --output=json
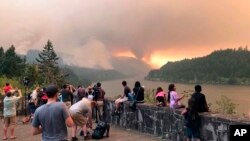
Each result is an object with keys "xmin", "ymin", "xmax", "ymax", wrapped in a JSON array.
[{"xmin": 182, "ymin": 98, "xmax": 201, "ymax": 141}]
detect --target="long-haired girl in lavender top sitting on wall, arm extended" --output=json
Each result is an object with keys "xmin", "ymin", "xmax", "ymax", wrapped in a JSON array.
[{"xmin": 168, "ymin": 84, "xmax": 185, "ymax": 109}]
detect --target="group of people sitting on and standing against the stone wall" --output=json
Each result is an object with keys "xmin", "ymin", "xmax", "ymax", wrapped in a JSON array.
[{"xmin": 113, "ymin": 81, "xmax": 209, "ymax": 141}]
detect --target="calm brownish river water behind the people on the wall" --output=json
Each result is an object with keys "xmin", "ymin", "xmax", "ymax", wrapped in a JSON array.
[{"xmin": 102, "ymin": 78, "xmax": 250, "ymax": 115}]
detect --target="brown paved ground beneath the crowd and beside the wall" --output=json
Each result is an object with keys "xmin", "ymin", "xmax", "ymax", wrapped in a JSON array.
[{"xmin": 0, "ymin": 117, "xmax": 165, "ymax": 141}]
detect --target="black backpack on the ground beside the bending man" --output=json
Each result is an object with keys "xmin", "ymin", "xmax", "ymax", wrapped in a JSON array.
[{"xmin": 92, "ymin": 121, "xmax": 110, "ymax": 139}]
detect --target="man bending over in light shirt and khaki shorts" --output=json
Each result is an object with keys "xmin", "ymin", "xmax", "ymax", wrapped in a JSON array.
[{"xmin": 69, "ymin": 98, "xmax": 95, "ymax": 141}]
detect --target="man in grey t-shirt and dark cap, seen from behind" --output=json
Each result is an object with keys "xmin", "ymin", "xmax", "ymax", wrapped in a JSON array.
[{"xmin": 32, "ymin": 85, "xmax": 74, "ymax": 141}]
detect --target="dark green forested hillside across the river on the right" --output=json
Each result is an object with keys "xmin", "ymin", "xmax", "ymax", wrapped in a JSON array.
[{"xmin": 146, "ymin": 47, "xmax": 250, "ymax": 84}]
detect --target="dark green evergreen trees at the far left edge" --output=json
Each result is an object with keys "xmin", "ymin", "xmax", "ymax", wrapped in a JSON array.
[{"xmin": 0, "ymin": 45, "xmax": 25, "ymax": 78}]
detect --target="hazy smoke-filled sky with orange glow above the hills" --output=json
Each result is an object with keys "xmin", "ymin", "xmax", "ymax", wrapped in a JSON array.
[{"xmin": 0, "ymin": 0, "xmax": 250, "ymax": 68}]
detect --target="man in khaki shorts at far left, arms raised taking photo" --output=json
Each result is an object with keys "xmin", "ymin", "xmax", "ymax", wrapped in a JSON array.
[{"xmin": 3, "ymin": 90, "xmax": 22, "ymax": 140}]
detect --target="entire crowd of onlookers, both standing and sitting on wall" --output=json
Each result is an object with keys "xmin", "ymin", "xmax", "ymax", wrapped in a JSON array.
[{"xmin": 0, "ymin": 81, "xmax": 248, "ymax": 141}]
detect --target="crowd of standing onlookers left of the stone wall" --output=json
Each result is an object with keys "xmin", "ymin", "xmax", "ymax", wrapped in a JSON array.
[{"xmin": 0, "ymin": 82, "xmax": 105, "ymax": 141}]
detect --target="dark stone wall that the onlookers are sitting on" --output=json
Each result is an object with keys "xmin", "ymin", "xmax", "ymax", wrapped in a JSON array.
[{"xmin": 105, "ymin": 99, "xmax": 250, "ymax": 141}]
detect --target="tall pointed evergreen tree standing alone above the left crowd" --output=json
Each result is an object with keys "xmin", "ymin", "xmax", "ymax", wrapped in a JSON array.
[{"xmin": 36, "ymin": 40, "xmax": 63, "ymax": 84}]
